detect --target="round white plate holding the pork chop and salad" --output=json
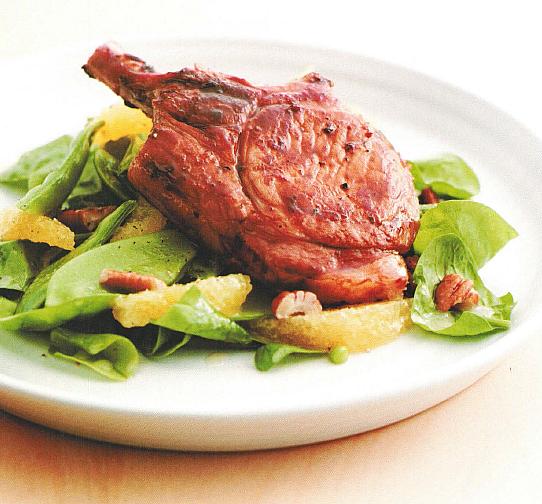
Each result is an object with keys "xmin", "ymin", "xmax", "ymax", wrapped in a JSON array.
[{"xmin": 0, "ymin": 41, "xmax": 542, "ymax": 450}]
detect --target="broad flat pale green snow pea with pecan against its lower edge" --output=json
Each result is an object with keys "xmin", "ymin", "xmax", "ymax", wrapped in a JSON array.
[{"xmin": 45, "ymin": 229, "xmax": 196, "ymax": 306}]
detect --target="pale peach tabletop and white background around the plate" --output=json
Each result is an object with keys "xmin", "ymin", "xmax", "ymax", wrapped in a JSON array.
[{"xmin": 0, "ymin": 0, "xmax": 542, "ymax": 504}]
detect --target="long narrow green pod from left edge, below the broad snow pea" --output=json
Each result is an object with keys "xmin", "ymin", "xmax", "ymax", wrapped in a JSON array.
[{"xmin": 0, "ymin": 294, "xmax": 116, "ymax": 331}]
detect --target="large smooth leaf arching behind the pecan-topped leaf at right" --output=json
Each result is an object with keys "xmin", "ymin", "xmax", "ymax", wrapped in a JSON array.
[{"xmin": 414, "ymin": 201, "xmax": 518, "ymax": 268}]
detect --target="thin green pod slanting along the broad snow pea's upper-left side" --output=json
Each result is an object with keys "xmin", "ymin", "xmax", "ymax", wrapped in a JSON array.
[{"xmin": 17, "ymin": 201, "xmax": 136, "ymax": 312}]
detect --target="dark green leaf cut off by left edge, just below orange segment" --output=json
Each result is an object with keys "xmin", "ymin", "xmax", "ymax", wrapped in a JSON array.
[{"xmin": 0, "ymin": 240, "xmax": 39, "ymax": 291}]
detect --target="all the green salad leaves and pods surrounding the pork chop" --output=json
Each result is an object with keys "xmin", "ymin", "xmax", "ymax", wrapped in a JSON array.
[{"xmin": 0, "ymin": 120, "xmax": 517, "ymax": 380}]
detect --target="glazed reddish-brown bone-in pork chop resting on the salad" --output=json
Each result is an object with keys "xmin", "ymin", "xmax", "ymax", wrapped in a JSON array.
[{"xmin": 84, "ymin": 46, "xmax": 419, "ymax": 304}]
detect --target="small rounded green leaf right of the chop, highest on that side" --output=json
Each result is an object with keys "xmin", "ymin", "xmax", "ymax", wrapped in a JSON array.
[{"xmin": 409, "ymin": 154, "xmax": 480, "ymax": 199}]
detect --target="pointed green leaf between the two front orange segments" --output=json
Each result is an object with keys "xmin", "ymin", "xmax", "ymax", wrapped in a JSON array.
[{"xmin": 152, "ymin": 286, "xmax": 251, "ymax": 343}]
